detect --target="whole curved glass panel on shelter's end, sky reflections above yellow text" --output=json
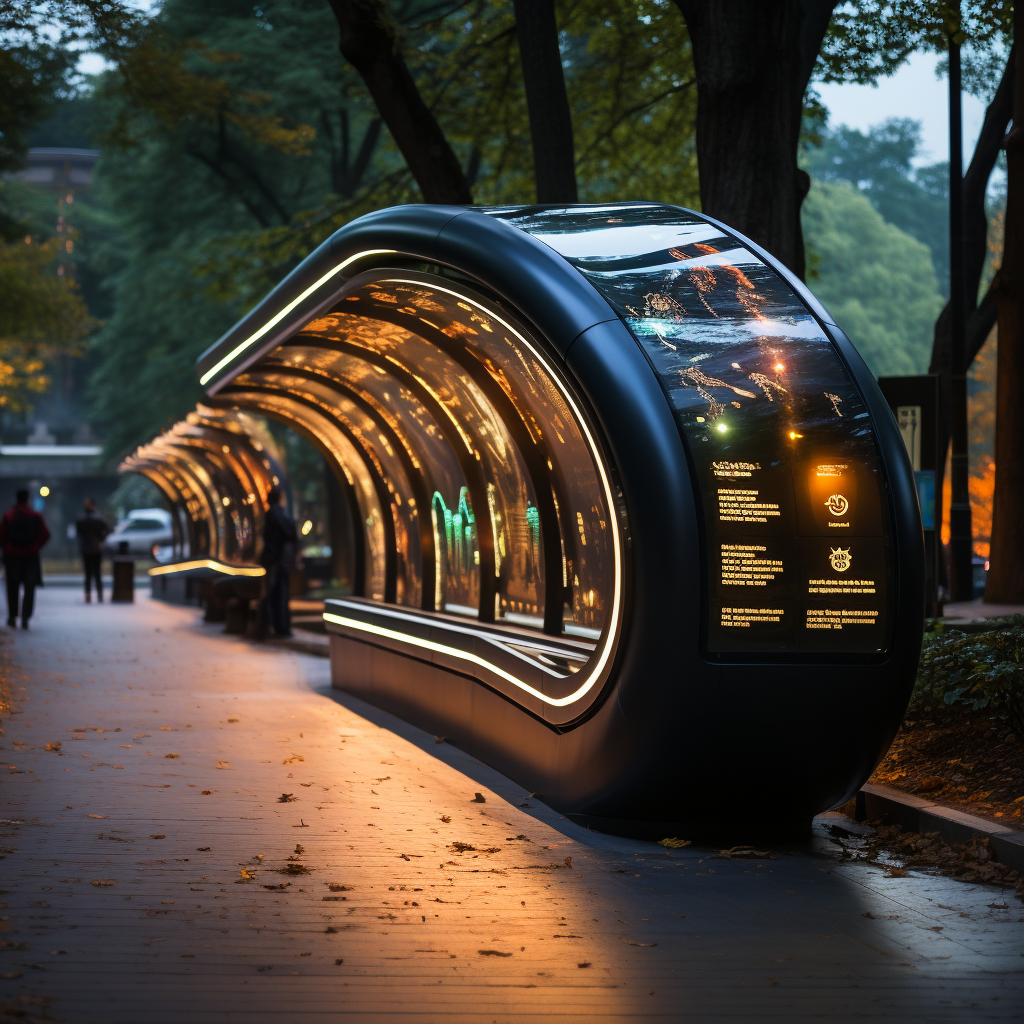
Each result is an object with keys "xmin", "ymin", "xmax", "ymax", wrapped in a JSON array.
[{"xmin": 495, "ymin": 204, "xmax": 891, "ymax": 652}]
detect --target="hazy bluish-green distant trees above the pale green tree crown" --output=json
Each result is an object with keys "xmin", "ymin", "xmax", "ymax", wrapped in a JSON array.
[{"xmin": 802, "ymin": 118, "xmax": 949, "ymax": 296}]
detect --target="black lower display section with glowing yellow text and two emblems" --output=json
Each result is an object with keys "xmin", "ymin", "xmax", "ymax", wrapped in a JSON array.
[{"xmin": 705, "ymin": 456, "xmax": 887, "ymax": 652}]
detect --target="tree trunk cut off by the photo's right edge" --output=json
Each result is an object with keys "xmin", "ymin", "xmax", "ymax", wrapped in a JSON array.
[{"xmin": 985, "ymin": 12, "xmax": 1024, "ymax": 604}]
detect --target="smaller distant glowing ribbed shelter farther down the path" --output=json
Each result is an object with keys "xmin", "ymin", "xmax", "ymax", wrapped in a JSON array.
[{"xmin": 120, "ymin": 406, "xmax": 288, "ymax": 578}]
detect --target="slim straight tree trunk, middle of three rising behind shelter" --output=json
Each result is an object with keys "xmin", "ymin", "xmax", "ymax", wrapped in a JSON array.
[{"xmin": 515, "ymin": 0, "xmax": 577, "ymax": 203}]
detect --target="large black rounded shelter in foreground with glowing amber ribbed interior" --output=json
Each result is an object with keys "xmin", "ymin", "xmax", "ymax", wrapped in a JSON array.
[{"xmin": 199, "ymin": 203, "xmax": 923, "ymax": 828}]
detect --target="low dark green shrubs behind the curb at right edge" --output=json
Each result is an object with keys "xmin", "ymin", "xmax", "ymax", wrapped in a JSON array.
[{"xmin": 911, "ymin": 615, "xmax": 1024, "ymax": 733}]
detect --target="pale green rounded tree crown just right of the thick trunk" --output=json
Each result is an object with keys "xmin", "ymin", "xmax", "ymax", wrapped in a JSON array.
[{"xmin": 803, "ymin": 182, "xmax": 942, "ymax": 376}]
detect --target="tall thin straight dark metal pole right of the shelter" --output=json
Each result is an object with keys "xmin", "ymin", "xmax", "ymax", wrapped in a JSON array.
[{"xmin": 949, "ymin": 16, "xmax": 974, "ymax": 601}]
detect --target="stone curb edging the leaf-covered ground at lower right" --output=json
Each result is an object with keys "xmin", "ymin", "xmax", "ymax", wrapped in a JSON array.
[{"xmin": 836, "ymin": 782, "xmax": 1024, "ymax": 874}]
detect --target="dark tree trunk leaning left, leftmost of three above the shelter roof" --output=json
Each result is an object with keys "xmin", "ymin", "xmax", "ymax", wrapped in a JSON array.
[{"xmin": 331, "ymin": 0, "xmax": 473, "ymax": 205}]
